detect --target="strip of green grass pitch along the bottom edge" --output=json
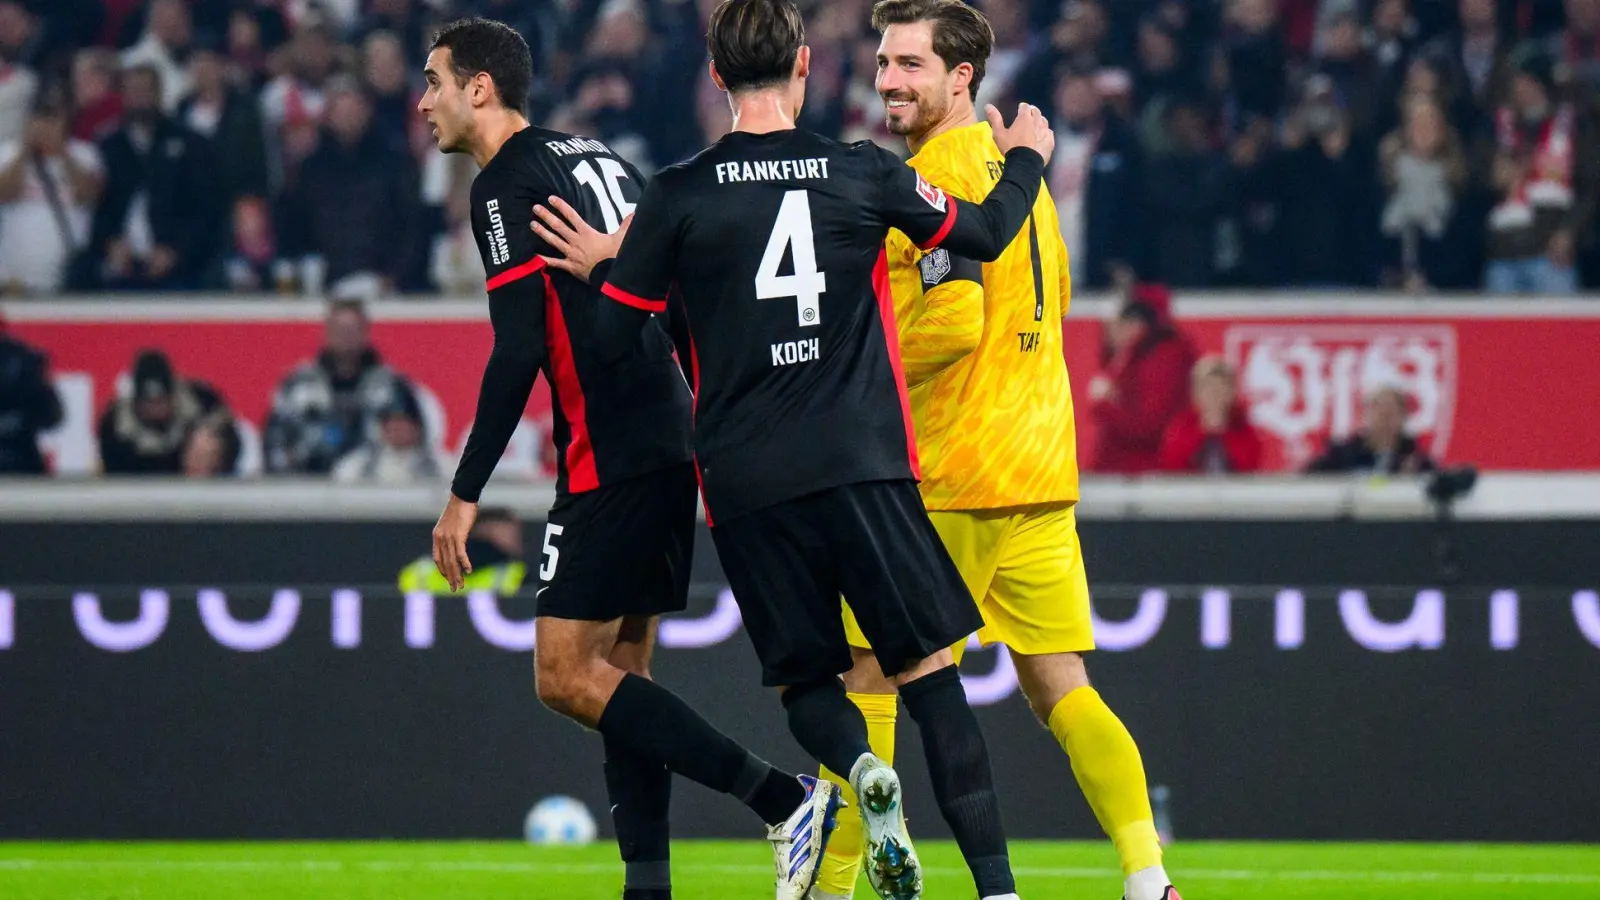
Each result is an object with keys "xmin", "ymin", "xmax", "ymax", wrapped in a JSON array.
[{"xmin": 0, "ymin": 841, "xmax": 1600, "ymax": 900}]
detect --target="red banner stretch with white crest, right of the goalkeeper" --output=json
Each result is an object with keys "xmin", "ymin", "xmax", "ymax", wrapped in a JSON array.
[{"xmin": 1064, "ymin": 299, "xmax": 1600, "ymax": 471}]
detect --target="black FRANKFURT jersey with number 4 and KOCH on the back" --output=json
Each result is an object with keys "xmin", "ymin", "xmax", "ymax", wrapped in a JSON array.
[{"xmin": 602, "ymin": 130, "xmax": 1043, "ymax": 520}]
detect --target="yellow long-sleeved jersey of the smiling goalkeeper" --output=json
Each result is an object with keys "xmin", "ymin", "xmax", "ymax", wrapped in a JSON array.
[{"xmin": 886, "ymin": 122, "xmax": 1078, "ymax": 509}]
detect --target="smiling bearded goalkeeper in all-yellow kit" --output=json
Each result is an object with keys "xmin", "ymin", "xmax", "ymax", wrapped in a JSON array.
[{"xmin": 811, "ymin": 0, "xmax": 1178, "ymax": 900}]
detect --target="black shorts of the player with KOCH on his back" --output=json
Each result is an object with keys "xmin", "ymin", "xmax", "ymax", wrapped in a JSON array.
[{"xmin": 710, "ymin": 480, "xmax": 984, "ymax": 687}]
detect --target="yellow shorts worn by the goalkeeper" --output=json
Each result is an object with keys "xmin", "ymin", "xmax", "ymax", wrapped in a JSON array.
[{"xmin": 845, "ymin": 503, "xmax": 1094, "ymax": 655}]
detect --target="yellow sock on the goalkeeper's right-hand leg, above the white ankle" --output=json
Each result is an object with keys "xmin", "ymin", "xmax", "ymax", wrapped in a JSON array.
[{"xmin": 1050, "ymin": 687, "xmax": 1162, "ymax": 874}]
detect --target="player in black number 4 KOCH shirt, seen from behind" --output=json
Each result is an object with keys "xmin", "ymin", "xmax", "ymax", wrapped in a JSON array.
[{"xmin": 539, "ymin": 0, "xmax": 1054, "ymax": 900}]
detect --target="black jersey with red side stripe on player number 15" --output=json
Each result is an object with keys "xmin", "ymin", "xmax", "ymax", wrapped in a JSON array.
[{"xmin": 451, "ymin": 128, "xmax": 693, "ymax": 501}]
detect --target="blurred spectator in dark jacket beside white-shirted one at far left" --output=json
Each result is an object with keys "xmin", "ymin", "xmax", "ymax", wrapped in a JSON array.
[{"xmin": 90, "ymin": 66, "xmax": 219, "ymax": 290}]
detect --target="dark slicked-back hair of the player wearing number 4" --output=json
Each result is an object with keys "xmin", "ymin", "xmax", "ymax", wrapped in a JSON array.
[{"xmin": 706, "ymin": 0, "xmax": 805, "ymax": 93}]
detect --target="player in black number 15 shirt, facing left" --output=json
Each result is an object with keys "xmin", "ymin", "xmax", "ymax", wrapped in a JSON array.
[{"xmin": 418, "ymin": 19, "xmax": 838, "ymax": 900}]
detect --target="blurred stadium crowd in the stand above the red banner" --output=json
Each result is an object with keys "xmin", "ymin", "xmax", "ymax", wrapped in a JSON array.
[{"xmin": 0, "ymin": 0, "xmax": 1600, "ymax": 296}]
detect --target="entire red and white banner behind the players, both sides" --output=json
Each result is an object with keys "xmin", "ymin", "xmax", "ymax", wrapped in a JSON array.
[{"xmin": 5, "ymin": 299, "xmax": 1600, "ymax": 476}]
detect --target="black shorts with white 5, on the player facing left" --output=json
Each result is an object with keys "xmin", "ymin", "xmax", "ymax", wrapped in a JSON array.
[{"xmin": 538, "ymin": 463, "xmax": 698, "ymax": 621}]
